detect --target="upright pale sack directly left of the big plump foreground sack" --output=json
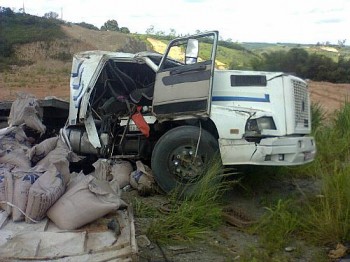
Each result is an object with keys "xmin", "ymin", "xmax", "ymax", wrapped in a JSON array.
[{"xmin": 25, "ymin": 165, "xmax": 66, "ymax": 223}]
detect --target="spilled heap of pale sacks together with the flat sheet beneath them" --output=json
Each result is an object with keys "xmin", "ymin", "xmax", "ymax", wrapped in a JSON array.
[{"xmin": 0, "ymin": 95, "xmax": 154, "ymax": 261}]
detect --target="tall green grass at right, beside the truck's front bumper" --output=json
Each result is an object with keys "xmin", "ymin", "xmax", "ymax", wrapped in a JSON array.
[{"xmin": 252, "ymin": 102, "xmax": 350, "ymax": 254}]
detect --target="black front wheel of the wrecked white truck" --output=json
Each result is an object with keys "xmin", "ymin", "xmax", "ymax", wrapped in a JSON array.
[{"xmin": 151, "ymin": 126, "xmax": 219, "ymax": 194}]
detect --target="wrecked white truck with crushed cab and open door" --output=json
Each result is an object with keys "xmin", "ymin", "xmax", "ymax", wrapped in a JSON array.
[{"xmin": 61, "ymin": 31, "xmax": 316, "ymax": 192}]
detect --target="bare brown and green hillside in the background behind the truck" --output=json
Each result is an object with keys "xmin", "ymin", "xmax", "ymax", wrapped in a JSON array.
[{"xmin": 0, "ymin": 10, "xmax": 350, "ymax": 114}]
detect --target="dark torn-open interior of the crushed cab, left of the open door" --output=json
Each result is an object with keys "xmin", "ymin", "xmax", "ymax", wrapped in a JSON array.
[{"xmin": 66, "ymin": 59, "xmax": 156, "ymax": 158}]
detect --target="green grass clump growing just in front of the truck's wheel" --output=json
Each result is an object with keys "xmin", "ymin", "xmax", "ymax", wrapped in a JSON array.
[{"xmin": 147, "ymin": 156, "xmax": 234, "ymax": 243}]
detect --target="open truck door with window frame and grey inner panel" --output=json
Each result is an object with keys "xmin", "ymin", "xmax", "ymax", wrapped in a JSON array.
[{"xmin": 152, "ymin": 31, "xmax": 218, "ymax": 120}]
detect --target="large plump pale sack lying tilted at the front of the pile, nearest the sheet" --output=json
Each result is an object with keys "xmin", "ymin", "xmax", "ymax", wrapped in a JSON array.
[{"xmin": 47, "ymin": 174, "xmax": 123, "ymax": 230}]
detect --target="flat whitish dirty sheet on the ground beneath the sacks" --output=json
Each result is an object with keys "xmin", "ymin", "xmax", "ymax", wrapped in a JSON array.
[{"xmin": 0, "ymin": 207, "xmax": 138, "ymax": 262}]
